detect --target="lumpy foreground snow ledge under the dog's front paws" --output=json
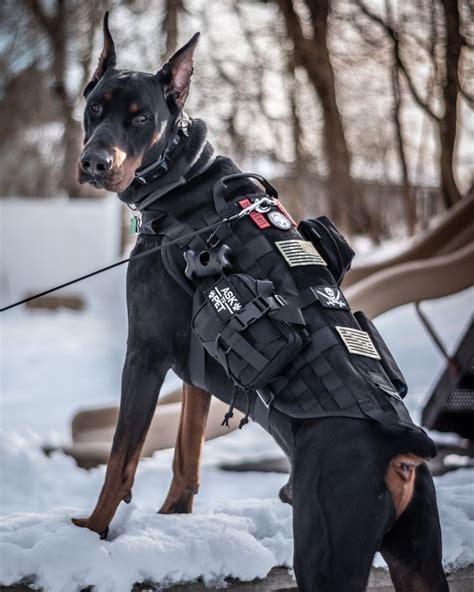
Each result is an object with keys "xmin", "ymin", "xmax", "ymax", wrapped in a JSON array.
[{"xmin": 0, "ymin": 500, "xmax": 292, "ymax": 592}]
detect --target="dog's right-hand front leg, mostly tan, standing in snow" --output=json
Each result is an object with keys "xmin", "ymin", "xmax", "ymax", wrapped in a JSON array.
[{"xmin": 160, "ymin": 384, "xmax": 211, "ymax": 514}]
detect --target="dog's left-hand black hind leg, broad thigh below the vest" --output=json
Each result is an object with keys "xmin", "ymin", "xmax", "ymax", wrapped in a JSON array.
[{"xmin": 292, "ymin": 418, "xmax": 393, "ymax": 592}]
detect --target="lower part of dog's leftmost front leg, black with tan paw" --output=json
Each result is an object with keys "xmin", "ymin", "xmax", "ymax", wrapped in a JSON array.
[{"xmin": 73, "ymin": 352, "xmax": 167, "ymax": 538}]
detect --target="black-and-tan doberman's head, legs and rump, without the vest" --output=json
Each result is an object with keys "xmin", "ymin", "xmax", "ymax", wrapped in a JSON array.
[{"xmin": 74, "ymin": 16, "xmax": 448, "ymax": 592}]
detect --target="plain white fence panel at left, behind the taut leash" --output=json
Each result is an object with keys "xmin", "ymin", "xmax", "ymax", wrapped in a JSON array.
[{"xmin": 0, "ymin": 197, "xmax": 125, "ymax": 306}]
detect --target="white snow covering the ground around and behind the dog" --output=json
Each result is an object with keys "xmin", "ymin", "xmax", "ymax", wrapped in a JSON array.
[{"xmin": 0, "ymin": 234, "xmax": 474, "ymax": 592}]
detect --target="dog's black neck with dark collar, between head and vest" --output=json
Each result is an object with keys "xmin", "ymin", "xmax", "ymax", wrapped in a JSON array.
[{"xmin": 119, "ymin": 119, "xmax": 214, "ymax": 211}]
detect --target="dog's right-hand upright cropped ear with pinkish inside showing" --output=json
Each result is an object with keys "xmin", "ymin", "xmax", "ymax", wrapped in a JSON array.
[{"xmin": 156, "ymin": 33, "xmax": 200, "ymax": 109}]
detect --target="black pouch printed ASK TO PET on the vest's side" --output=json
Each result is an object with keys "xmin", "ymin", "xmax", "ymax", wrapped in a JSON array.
[{"xmin": 192, "ymin": 274, "xmax": 307, "ymax": 389}]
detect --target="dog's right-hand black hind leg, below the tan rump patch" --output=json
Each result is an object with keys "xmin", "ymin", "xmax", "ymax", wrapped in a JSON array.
[{"xmin": 381, "ymin": 464, "xmax": 449, "ymax": 592}]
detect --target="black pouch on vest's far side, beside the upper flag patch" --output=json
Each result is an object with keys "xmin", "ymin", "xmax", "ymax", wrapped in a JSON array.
[{"xmin": 298, "ymin": 216, "xmax": 354, "ymax": 286}]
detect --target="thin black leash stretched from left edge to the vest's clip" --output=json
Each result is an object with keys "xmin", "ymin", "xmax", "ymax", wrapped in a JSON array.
[{"xmin": 0, "ymin": 197, "xmax": 275, "ymax": 312}]
